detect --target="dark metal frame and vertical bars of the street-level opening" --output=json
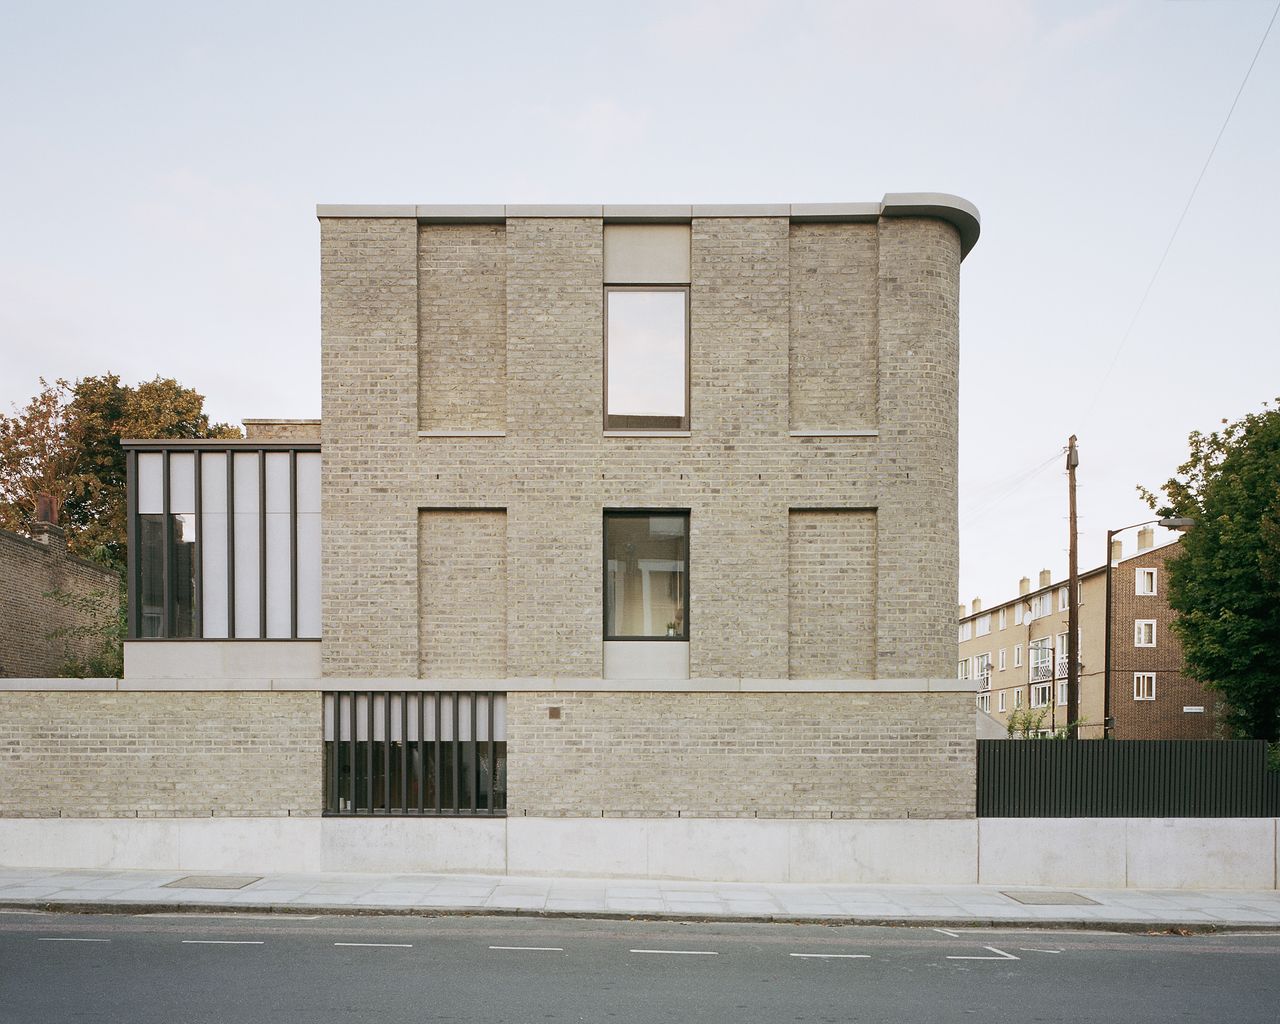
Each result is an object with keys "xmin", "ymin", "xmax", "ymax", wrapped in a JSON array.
[{"xmin": 323, "ymin": 690, "xmax": 507, "ymax": 818}]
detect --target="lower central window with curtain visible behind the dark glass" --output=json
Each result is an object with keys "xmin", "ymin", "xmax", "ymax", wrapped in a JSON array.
[{"xmin": 604, "ymin": 511, "xmax": 689, "ymax": 640}]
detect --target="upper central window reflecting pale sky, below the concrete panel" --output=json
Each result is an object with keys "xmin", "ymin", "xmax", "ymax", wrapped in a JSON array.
[{"xmin": 604, "ymin": 287, "xmax": 689, "ymax": 430}]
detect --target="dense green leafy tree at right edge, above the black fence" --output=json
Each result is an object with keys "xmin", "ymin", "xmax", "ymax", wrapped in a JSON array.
[{"xmin": 1139, "ymin": 403, "xmax": 1280, "ymax": 742}]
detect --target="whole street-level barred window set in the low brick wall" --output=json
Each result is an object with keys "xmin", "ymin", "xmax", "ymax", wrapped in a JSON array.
[{"xmin": 324, "ymin": 691, "xmax": 507, "ymax": 815}]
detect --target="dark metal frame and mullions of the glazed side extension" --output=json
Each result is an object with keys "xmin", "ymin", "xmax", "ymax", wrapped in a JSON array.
[{"xmin": 122, "ymin": 439, "xmax": 320, "ymax": 643}]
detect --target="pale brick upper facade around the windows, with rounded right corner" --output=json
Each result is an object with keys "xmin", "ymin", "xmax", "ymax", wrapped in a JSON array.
[{"xmin": 321, "ymin": 218, "xmax": 960, "ymax": 678}]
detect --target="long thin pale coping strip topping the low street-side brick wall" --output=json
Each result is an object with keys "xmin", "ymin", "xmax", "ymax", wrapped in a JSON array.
[{"xmin": 0, "ymin": 676, "xmax": 975, "ymax": 694}]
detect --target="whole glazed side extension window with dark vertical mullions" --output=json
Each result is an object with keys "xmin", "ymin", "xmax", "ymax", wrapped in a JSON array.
[{"xmin": 127, "ymin": 440, "xmax": 320, "ymax": 640}]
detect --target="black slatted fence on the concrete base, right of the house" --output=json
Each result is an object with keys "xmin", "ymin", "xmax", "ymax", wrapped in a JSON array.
[{"xmin": 978, "ymin": 740, "xmax": 1280, "ymax": 818}]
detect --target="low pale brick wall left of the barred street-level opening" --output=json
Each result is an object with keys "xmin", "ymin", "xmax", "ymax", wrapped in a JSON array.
[{"xmin": 0, "ymin": 691, "xmax": 323, "ymax": 818}]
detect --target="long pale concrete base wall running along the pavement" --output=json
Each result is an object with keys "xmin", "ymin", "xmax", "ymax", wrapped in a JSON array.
[{"xmin": 0, "ymin": 818, "xmax": 1280, "ymax": 890}]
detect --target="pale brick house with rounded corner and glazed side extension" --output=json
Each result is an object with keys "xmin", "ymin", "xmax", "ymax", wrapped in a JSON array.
[{"xmin": 0, "ymin": 195, "xmax": 978, "ymax": 877}]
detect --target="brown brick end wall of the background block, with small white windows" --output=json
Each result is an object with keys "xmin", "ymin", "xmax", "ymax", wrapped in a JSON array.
[{"xmin": 1111, "ymin": 543, "xmax": 1219, "ymax": 740}]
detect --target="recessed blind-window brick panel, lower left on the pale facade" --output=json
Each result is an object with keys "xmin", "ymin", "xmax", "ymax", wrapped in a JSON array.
[{"xmin": 417, "ymin": 509, "xmax": 507, "ymax": 678}]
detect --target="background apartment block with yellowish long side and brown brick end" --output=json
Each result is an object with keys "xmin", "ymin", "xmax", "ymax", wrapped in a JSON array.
[{"xmin": 956, "ymin": 527, "xmax": 1219, "ymax": 740}]
